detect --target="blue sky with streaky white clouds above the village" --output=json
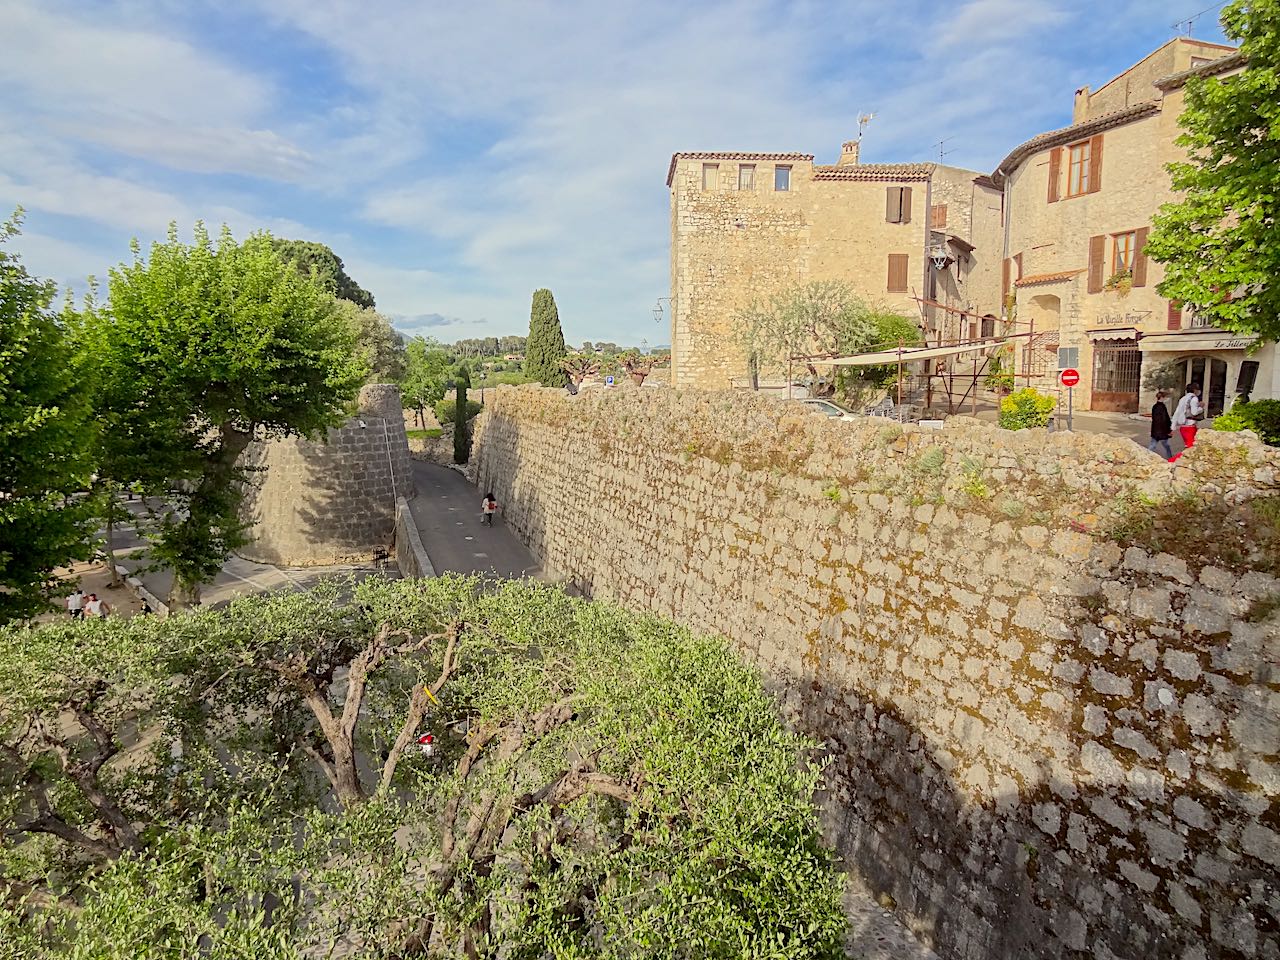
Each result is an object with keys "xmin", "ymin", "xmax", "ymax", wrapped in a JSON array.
[{"xmin": 0, "ymin": 0, "xmax": 1221, "ymax": 343}]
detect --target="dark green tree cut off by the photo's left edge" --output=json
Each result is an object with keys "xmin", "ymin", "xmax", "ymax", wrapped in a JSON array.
[{"xmin": 0, "ymin": 210, "xmax": 93, "ymax": 623}]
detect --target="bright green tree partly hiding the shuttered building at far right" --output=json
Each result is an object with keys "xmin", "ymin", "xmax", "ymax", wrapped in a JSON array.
[{"xmin": 1146, "ymin": 0, "xmax": 1280, "ymax": 340}]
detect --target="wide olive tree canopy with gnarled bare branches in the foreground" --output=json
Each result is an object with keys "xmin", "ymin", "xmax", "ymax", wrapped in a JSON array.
[{"xmin": 0, "ymin": 576, "xmax": 845, "ymax": 960}]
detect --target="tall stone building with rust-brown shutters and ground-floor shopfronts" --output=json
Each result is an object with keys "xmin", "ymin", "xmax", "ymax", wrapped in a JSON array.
[{"xmin": 992, "ymin": 37, "xmax": 1280, "ymax": 416}]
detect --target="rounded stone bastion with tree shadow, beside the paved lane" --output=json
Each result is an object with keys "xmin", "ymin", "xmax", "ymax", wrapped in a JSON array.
[{"xmin": 239, "ymin": 384, "xmax": 413, "ymax": 567}]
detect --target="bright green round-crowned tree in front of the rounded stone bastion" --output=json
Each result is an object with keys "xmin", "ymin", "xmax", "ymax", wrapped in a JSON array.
[{"xmin": 91, "ymin": 224, "xmax": 366, "ymax": 607}]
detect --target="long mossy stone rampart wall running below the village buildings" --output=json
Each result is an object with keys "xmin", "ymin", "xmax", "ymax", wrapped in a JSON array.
[{"xmin": 475, "ymin": 387, "xmax": 1280, "ymax": 960}]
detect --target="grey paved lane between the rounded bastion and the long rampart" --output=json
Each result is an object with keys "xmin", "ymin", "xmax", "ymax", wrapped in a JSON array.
[{"xmin": 408, "ymin": 461, "xmax": 543, "ymax": 577}]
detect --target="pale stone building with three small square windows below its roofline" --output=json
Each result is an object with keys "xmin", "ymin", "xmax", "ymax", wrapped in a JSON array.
[{"xmin": 667, "ymin": 141, "xmax": 1001, "ymax": 387}]
